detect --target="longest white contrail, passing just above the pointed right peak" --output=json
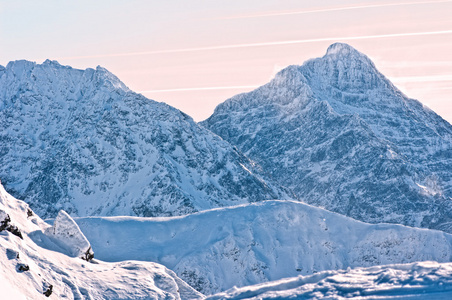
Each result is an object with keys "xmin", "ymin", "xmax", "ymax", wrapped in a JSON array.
[{"xmin": 55, "ymin": 30, "xmax": 452, "ymax": 60}]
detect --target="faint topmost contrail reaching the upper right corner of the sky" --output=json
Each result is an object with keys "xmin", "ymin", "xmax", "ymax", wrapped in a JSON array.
[{"xmin": 216, "ymin": 0, "xmax": 452, "ymax": 20}]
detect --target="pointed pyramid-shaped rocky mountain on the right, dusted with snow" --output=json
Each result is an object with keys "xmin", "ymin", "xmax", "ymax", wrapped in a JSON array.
[{"xmin": 202, "ymin": 43, "xmax": 452, "ymax": 232}]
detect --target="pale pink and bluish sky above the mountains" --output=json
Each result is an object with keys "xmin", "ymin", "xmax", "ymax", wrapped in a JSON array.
[{"xmin": 0, "ymin": 0, "xmax": 452, "ymax": 123}]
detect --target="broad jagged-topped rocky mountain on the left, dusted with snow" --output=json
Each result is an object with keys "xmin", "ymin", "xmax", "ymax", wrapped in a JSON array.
[{"xmin": 0, "ymin": 60, "xmax": 291, "ymax": 217}]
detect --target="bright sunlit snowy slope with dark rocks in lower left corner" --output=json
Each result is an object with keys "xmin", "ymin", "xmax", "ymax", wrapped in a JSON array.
[{"xmin": 0, "ymin": 180, "xmax": 203, "ymax": 300}]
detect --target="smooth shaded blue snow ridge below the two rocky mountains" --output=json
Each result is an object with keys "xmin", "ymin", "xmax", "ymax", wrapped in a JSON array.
[{"xmin": 75, "ymin": 201, "xmax": 452, "ymax": 294}]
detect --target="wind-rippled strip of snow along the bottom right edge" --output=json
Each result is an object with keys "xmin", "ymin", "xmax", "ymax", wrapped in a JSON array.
[{"xmin": 207, "ymin": 262, "xmax": 452, "ymax": 300}]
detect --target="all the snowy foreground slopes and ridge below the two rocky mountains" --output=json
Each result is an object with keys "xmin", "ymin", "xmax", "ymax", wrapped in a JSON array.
[{"xmin": 0, "ymin": 179, "xmax": 452, "ymax": 300}]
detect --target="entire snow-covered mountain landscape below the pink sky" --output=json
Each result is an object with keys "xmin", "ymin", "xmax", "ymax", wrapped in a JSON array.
[{"xmin": 0, "ymin": 43, "xmax": 452, "ymax": 299}]
